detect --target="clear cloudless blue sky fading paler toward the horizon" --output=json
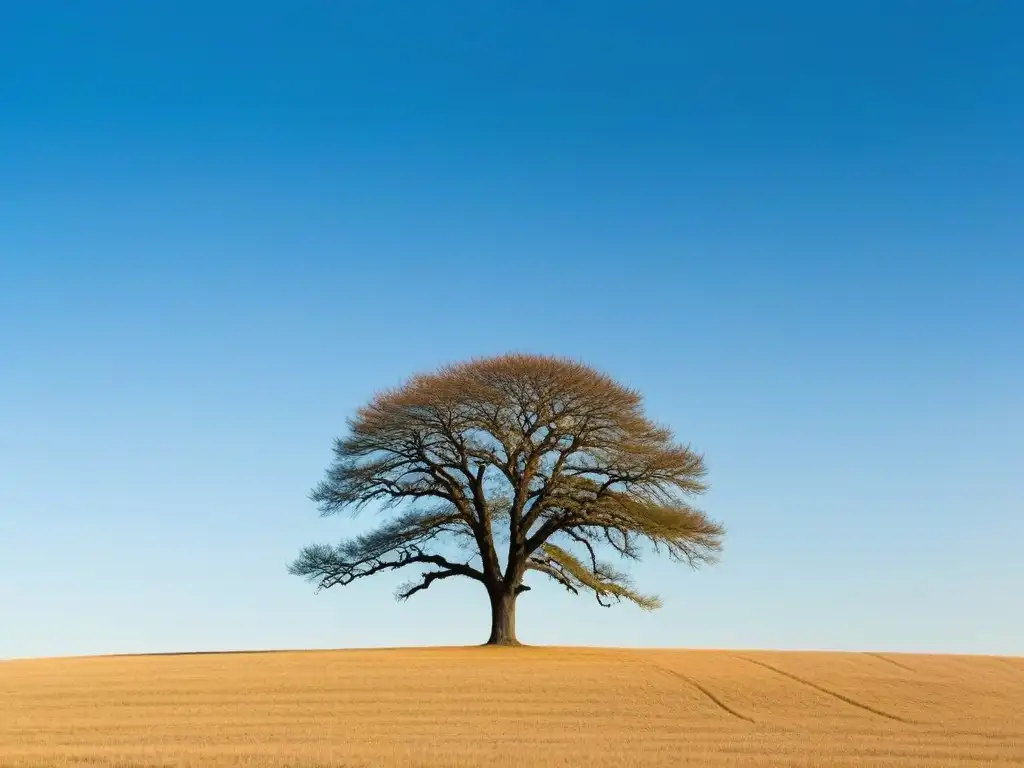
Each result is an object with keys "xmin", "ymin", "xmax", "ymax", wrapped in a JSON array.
[{"xmin": 0, "ymin": 0, "xmax": 1024, "ymax": 657}]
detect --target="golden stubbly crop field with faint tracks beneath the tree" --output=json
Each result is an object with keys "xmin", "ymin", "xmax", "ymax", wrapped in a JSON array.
[{"xmin": 0, "ymin": 648, "xmax": 1024, "ymax": 768}]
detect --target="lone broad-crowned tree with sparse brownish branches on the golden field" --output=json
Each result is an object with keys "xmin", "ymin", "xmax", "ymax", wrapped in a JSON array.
[{"xmin": 289, "ymin": 354, "xmax": 724, "ymax": 645}]
